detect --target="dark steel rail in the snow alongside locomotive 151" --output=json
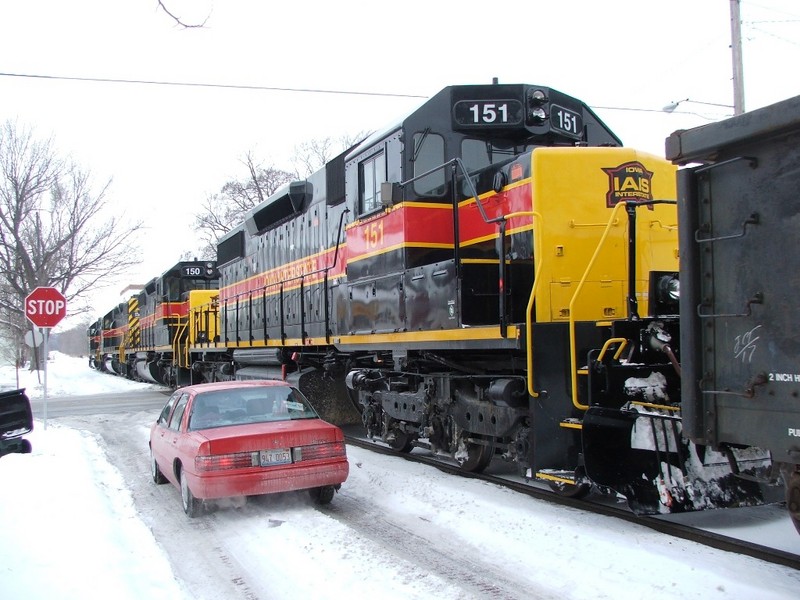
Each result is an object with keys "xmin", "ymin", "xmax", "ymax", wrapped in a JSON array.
[{"xmin": 345, "ymin": 429, "xmax": 800, "ymax": 570}]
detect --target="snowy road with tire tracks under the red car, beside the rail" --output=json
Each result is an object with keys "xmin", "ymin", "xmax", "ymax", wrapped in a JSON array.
[{"xmin": 57, "ymin": 411, "xmax": 800, "ymax": 600}]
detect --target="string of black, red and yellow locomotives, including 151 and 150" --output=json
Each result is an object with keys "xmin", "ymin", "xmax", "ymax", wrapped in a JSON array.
[{"xmin": 88, "ymin": 81, "xmax": 800, "ymax": 524}]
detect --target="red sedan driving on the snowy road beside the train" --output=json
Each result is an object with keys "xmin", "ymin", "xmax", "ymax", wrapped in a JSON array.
[{"xmin": 150, "ymin": 380, "xmax": 350, "ymax": 517}]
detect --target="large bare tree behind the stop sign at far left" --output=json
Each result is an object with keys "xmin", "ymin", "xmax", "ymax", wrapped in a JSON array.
[{"xmin": 0, "ymin": 121, "xmax": 141, "ymax": 366}]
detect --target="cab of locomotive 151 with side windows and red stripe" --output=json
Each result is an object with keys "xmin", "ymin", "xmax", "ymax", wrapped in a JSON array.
[{"xmin": 338, "ymin": 84, "xmax": 621, "ymax": 335}]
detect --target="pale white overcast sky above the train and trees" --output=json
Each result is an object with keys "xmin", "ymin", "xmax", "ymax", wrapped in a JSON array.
[{"xmin": 0, "ymin": 0, "xmax": 800, "ymax": 324}]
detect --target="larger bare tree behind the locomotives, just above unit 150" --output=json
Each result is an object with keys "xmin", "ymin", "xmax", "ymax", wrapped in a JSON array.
[{"xmin": 194, "ymin": 152, "xmax": 292, "ymax": 259}]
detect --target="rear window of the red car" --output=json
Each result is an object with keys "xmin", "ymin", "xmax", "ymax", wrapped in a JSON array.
[{"xmin": 189, "ymin": 386, "xmax": 319, "ymax": 430}]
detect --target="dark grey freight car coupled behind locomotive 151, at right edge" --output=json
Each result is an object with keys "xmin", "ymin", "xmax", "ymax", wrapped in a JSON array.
[{"xmin": 666, "ymin": 96, "xmax": 800, "ymax": 531}]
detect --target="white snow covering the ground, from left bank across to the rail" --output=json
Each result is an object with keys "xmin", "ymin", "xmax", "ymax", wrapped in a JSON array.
[{"xmin": 0, "ymin": 354, "xmax": 800, "ymax": 600}]
